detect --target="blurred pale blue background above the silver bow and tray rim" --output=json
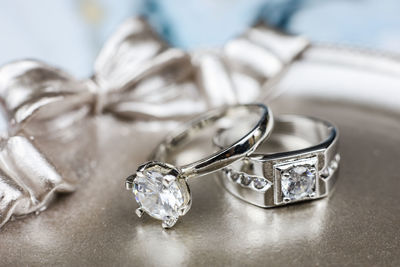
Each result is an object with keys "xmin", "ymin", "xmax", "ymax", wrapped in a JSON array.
[{"xmin": 0, "ymin": 0, "xmax": 400, "ymax": 77}]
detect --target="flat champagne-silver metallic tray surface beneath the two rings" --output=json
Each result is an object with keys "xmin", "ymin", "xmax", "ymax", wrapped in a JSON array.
[{"xmin": 0, "ymin": 47, "xmax": 400, "ymax": 266}]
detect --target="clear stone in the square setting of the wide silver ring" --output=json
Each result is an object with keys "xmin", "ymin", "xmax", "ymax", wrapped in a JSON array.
[{"xmin": 281, "ymin": 165, "xmax": 316, "ymax": 200}]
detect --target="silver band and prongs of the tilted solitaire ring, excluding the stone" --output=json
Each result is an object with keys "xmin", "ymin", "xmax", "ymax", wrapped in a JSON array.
[{"xmin": 126, "ymin": 104, "xmax": 273, "ymax": 228}]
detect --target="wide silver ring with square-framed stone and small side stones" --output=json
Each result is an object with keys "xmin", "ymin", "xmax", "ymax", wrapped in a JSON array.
[{"xmin": 213, "ymin": 115, "xmax": 340, "ymax": 207}]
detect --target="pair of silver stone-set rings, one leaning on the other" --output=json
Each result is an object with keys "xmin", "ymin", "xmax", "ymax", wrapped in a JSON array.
[{"xmin": 126, "ymin": 104, "xmax": 340, "ymax": 228}]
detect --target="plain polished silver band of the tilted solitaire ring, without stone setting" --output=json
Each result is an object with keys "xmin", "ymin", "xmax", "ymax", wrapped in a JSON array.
[{"xmin": 151, "ymin": 104, "xmax": 273, "ymax": 179}]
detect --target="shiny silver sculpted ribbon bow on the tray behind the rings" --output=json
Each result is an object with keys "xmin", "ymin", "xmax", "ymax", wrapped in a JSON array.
[{"xmin": 0, "ymin": 19, "xmax": 308, "ymax": 227}]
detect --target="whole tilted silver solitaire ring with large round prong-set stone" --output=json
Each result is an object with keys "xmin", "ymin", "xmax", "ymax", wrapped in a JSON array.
[{"xmin": 126, "ymin": 104, "xmax": 273, "ymax": 228}]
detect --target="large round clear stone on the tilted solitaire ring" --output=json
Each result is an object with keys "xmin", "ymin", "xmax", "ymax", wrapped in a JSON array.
[{"xmin": 133, "ymin": 163, "xmax": 189, "ymax": 221}]
